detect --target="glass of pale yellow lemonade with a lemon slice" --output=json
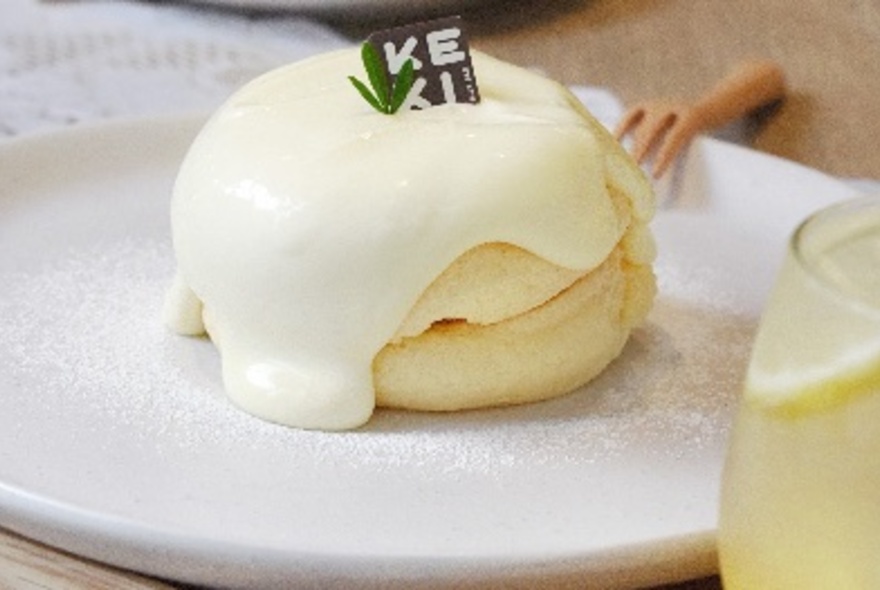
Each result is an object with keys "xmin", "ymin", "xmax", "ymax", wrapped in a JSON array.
[{"xmin": 719, "ymin": 198, "xmax": 880, "ymax": 590}]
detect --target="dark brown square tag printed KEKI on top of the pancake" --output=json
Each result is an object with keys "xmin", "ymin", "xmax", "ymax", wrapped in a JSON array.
[{"xmin": 367, "ymin": 16, "xmax": 480, "ymax": 110}]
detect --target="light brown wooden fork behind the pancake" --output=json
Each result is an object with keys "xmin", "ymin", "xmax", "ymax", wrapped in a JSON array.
[{"xmin": 614, "ymin": 60, "xmax": 785, "ymax": 178}]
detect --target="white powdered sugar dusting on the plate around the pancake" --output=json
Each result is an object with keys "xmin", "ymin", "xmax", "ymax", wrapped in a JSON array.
[{"xmin": 0, "ymin": 238, "xmax": 754, "ymax": 473}]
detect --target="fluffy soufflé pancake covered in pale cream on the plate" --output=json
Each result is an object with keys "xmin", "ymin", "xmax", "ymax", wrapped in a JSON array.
[{"xmin": 166, "ymin": 49, "xmax": 655, "ymax": 430}]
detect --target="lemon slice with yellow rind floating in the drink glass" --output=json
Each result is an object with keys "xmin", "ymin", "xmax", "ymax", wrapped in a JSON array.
[{"xmin": 745, "ymin": 206, "xmax": 880, "ymax": 416}]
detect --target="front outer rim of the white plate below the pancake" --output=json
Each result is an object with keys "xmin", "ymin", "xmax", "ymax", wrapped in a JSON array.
[{"xmin": 0, "ymin": 481, "xmax": 717, "ymax": 589}]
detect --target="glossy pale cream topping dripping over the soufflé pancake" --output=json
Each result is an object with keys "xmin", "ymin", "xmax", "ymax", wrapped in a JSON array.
[{"xmin": 166, "ymin": 49, "xmax": 653, "ymax": 430}]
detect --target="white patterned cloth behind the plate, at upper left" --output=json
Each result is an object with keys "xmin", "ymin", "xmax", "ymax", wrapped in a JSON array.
[{"xmin": 0, "ymin": 0, "xmax": 348, "ymax": 137}]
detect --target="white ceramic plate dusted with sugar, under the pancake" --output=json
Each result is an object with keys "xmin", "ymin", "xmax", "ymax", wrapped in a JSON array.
[{"xmin": 0, "ymin": 120, "xmax": 853, "ymax": 588}]
